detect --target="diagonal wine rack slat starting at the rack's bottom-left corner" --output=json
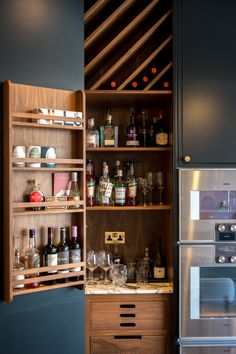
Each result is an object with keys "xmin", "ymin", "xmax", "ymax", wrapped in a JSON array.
[{"xmin": 90, "ymin": 10, "xmax": 172, "ymax": 90}]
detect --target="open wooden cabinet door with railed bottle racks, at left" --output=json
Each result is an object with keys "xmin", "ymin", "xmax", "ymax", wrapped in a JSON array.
[{"xmin": 4, "ymin": 81, "xmax": 85, "ymax": 301}]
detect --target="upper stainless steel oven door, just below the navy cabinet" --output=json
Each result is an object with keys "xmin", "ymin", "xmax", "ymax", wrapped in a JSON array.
[{"xmin": 179, "ymin": 169, "xmax": 236, "ymax": 243}]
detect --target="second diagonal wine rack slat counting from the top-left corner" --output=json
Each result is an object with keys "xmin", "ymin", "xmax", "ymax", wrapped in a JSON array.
[{"xmin": 84, "ymin": 0, "xmax": 136, "ymax": 50}]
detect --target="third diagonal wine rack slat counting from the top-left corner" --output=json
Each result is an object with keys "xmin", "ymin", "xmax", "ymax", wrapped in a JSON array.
[{"xmin": 84, "ymin": 0, "xmax": 160, "ymax": 75}]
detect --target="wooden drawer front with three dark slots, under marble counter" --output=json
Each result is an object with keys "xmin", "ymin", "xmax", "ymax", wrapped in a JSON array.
[{"xmin": 90, "ymin": 301, "xmax": 165, "ymax": 331}]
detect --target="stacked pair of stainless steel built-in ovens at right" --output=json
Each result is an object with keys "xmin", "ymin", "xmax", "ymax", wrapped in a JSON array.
[{"xmin": 178, "ymin": 169, "xmax": 236, "ymax": 354}]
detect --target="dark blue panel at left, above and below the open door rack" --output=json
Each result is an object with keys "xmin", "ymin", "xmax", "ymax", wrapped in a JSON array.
[{"xmin": 0, "ymin": 0, "xmax": 85, "ymax": 354}]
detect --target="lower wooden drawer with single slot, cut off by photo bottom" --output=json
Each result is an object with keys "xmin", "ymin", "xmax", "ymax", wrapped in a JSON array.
[{"xmin": 91, "ymin": 335, "xmax": 165, "ymax": 354}]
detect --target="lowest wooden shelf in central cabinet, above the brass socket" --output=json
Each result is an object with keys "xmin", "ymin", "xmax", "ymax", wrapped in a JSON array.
[{"xmin": 86, "ymin": 205, "xmax": 171, "ymax": 211}]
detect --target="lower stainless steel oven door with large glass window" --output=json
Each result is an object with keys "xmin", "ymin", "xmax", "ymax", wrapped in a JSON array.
[{"xmin": 179, "ymin": 245, "xmax": 236, "ymax": 338}]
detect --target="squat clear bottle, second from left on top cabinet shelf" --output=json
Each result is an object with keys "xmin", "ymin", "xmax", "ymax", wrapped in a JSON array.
[{"xmin": 99, "ymin": 110, "xmax": 118, "ymax": 147}]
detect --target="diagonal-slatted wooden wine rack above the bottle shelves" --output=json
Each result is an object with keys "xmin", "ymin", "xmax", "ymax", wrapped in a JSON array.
[{"xmin": 84, "ymin": 0, "xmax": 172, "ymax": 91}]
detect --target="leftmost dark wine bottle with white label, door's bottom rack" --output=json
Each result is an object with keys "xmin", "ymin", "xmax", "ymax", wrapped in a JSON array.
[{"xmin": 43, "ymin": 227, "xmax": 58, "ymax": 285}]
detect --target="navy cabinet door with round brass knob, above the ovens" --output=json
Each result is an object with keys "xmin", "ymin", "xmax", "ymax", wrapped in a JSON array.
[{"xmin": 175, "ymin": 0, "xmax": 236, "ymax": 166}]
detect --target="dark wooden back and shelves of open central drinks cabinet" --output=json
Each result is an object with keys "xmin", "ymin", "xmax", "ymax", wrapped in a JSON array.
[{"xmin": 85, "ymin": 90, "xmax": 173, "ymax": 281}]
